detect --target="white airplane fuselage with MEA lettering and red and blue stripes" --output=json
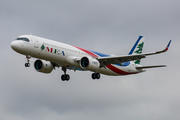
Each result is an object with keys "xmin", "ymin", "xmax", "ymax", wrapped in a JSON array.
[{"xmin": 11, "ymin": 35, "xmax": 142, "ymax": 75}]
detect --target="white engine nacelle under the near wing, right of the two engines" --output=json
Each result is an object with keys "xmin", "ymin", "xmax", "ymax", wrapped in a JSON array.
[{"xmin": 79, "ymin": 57, "xmax": 100, "ymax": 71}]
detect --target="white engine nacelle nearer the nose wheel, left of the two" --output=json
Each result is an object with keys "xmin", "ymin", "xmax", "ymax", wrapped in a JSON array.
[{"xmin": 34, "ymin": 60, "xmax": 54, "ymax": 73}]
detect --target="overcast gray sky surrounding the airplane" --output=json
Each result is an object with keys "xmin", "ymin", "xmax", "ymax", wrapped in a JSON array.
[{"xmin": 0, "ymin": 0, "xmax": 180, "ymax": 120}]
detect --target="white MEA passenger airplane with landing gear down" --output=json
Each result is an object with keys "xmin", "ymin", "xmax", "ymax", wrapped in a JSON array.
[{"xmin": 11, "ymin": 35, "xmax": 171, "ymax": 81}]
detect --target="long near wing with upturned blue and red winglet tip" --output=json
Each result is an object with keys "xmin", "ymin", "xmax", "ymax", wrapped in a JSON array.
[{"xmin": 97, "ymin": 40, "xmax": 171, "ymax": 67}]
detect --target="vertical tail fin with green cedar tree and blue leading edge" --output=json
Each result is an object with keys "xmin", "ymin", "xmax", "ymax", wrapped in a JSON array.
[{"xmin": 129, "ymin": 36, "xmax": 144, "ymax": 64}]
